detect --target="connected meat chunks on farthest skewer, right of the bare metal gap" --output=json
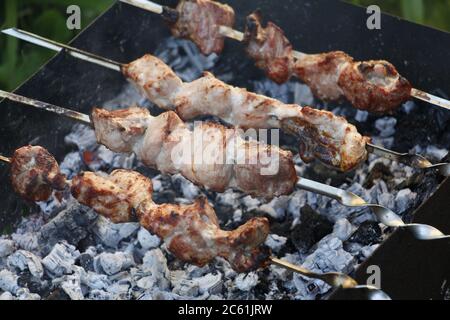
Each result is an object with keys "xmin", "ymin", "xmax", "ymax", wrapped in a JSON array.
[{"xmin": 244, "ymin": 12, "xmax": 412, "ymax": 113}]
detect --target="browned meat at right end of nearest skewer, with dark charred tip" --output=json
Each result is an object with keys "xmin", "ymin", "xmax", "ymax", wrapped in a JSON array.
[{"xmin": 139, "ymin": 198, "xmax": 270, "ymax": 272}]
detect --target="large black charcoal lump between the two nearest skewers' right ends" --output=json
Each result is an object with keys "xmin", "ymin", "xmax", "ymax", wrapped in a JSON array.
[{"xmin": 290, "ymin": 206, "xmax": 333, "ymax": 252}]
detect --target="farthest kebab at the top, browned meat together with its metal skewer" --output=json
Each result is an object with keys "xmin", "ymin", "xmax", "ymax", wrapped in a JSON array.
[{"xmin": 120, "ymin": 0, "xmax": 450, "ymax": 113}]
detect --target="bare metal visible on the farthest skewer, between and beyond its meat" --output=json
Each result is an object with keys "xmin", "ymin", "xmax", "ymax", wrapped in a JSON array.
[{"xmin": 120, "ymin": 0, "xmax": 450, "ymax": 110}]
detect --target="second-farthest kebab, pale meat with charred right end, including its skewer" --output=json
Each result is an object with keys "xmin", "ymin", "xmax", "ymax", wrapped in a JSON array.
[{"xmin": 2, "ymin": 28, "xmax": 450, "ymax": 176}]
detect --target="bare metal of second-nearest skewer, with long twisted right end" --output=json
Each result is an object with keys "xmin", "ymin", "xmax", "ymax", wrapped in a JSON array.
[{"xmin": 0, "ymin": 90, "xmax": 450, "ymax": 240}]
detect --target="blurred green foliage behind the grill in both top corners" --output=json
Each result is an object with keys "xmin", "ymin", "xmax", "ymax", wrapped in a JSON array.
[{"xmin": 0, "ymin": 0, "xmax": 450, "ymax": 90}]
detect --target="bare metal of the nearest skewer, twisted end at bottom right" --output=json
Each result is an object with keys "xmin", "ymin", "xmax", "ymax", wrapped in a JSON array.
[{"xmin": 0, "ymin": 155, "xmax": 390, "ymax": 300}]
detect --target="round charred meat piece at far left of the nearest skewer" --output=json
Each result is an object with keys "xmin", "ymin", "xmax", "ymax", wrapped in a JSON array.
[{"xmin": 11, "ymin": 146, "xmax": 66, "ymax": 201}]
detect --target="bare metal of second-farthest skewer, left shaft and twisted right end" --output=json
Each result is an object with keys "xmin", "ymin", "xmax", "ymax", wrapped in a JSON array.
[{"xmin": 2, "ymin": 27, "xmax": 450, "ymax": 177}]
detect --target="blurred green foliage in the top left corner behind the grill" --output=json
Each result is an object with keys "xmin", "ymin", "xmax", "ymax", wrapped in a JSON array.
[{"xmin": 0, "ymin": 0, "xmax": 113, "ymax": 90}]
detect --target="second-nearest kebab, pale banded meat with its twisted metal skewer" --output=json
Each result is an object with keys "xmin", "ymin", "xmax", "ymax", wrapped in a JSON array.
[{"xmin": 0, "ymin": 90, "xmax": 448, "ymax": 240}]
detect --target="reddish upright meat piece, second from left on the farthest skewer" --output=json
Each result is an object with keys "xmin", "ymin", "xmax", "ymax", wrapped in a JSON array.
[{"xmin": 244, "ymin": 12, "xmax": 293, "ymax": 84}]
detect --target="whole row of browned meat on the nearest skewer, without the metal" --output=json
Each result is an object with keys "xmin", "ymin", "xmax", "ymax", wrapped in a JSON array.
[{"xmin": 11, "ymin": 146, "xmax": 270, "ymax": 272}]
